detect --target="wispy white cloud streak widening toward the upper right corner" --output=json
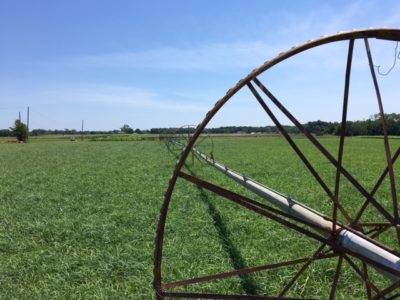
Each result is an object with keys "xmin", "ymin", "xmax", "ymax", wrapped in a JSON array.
[{"xmin": 36, "ymin": 0, "xmax": 400, "ymax": 79}]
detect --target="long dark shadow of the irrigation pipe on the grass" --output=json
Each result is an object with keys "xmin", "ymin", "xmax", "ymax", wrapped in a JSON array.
[{"xmin": 186, "ymin": 165, "xmax": 257, "ymax": 295}]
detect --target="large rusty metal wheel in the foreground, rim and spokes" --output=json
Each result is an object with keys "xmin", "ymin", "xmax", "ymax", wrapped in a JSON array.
[{"xmin": 154, "ymin": 29, "xmax": 400, "ymax": 299}]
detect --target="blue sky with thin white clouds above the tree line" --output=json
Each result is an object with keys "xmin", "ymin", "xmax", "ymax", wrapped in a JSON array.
[{"xmin": 0, "ymin": 0, "xmax": 400, "ymax": 130}]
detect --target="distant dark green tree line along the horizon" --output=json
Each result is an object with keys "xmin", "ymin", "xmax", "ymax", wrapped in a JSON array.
[{"xmin": 0, "ymin": 113, "xmax": 400, "ymax": 137}]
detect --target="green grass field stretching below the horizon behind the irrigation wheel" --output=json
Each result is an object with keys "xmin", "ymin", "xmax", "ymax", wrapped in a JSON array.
[{"xmin": 0, "ymin": 137, "xmax": 400, "ymax": 299}]
